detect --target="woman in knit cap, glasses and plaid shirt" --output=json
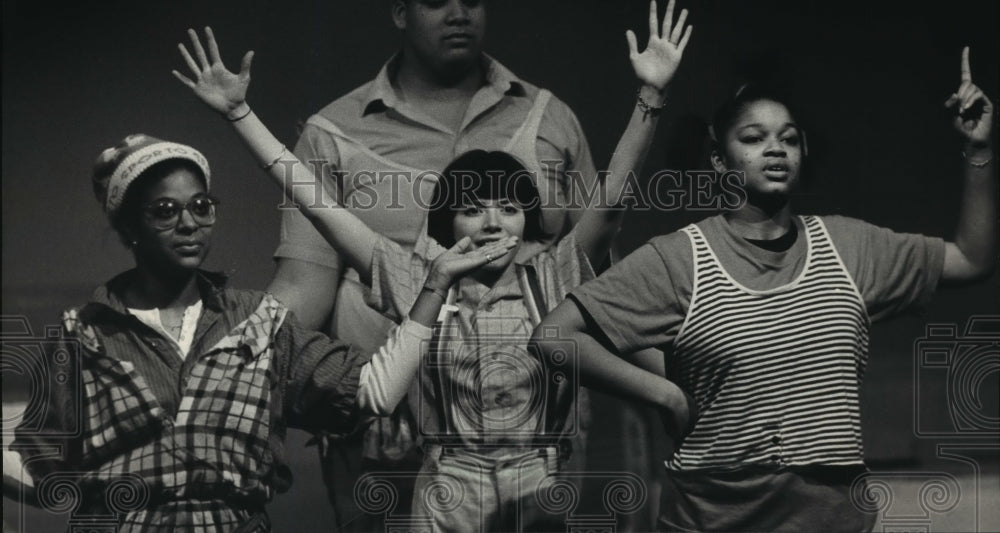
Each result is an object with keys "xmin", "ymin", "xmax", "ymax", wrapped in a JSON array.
[{"xmin": 11, "ymin": 134, "xmax": 501, "ymax": 532}]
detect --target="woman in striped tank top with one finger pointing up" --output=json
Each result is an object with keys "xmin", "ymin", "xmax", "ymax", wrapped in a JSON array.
[{"xmin": 536, "ymin": 49, "xmax": 997, "ymax": 531}]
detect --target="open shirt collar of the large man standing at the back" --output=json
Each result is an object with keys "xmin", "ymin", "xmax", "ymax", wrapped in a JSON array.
[{"xmin": 361, "ymin": 52, "xmax": 527, "ymax": 127}]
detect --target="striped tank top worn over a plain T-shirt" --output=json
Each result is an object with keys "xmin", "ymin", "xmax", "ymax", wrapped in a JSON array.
[{"xmin": 667, "ymin": 217, "xmax": 870, "ymax": 470}]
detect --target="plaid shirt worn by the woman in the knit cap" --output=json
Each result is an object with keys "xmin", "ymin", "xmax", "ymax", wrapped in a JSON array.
[{"xmin": 12, "ymin": 273, "xmax": 370, "ymax": 531}]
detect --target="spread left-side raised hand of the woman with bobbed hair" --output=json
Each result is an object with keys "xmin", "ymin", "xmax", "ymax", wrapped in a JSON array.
[{"xmin": 172, "ymin": 27, "xmax": 253, "ymax": 115}]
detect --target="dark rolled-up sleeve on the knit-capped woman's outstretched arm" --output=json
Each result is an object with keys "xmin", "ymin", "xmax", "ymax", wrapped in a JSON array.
[{"xmin": 275, "ymin": 314, "xmax": 371, "ymax": 434}]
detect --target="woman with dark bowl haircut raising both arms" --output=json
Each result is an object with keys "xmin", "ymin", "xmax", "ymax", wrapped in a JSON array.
[{"xmin": 174, "ymin": 0, "xmax": 691, "ymax": 531}]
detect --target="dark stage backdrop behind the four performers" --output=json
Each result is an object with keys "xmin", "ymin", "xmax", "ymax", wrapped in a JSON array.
[{"xmin": 2, "ymin": 0, "xmax": 1000, "ymax": 528}]
